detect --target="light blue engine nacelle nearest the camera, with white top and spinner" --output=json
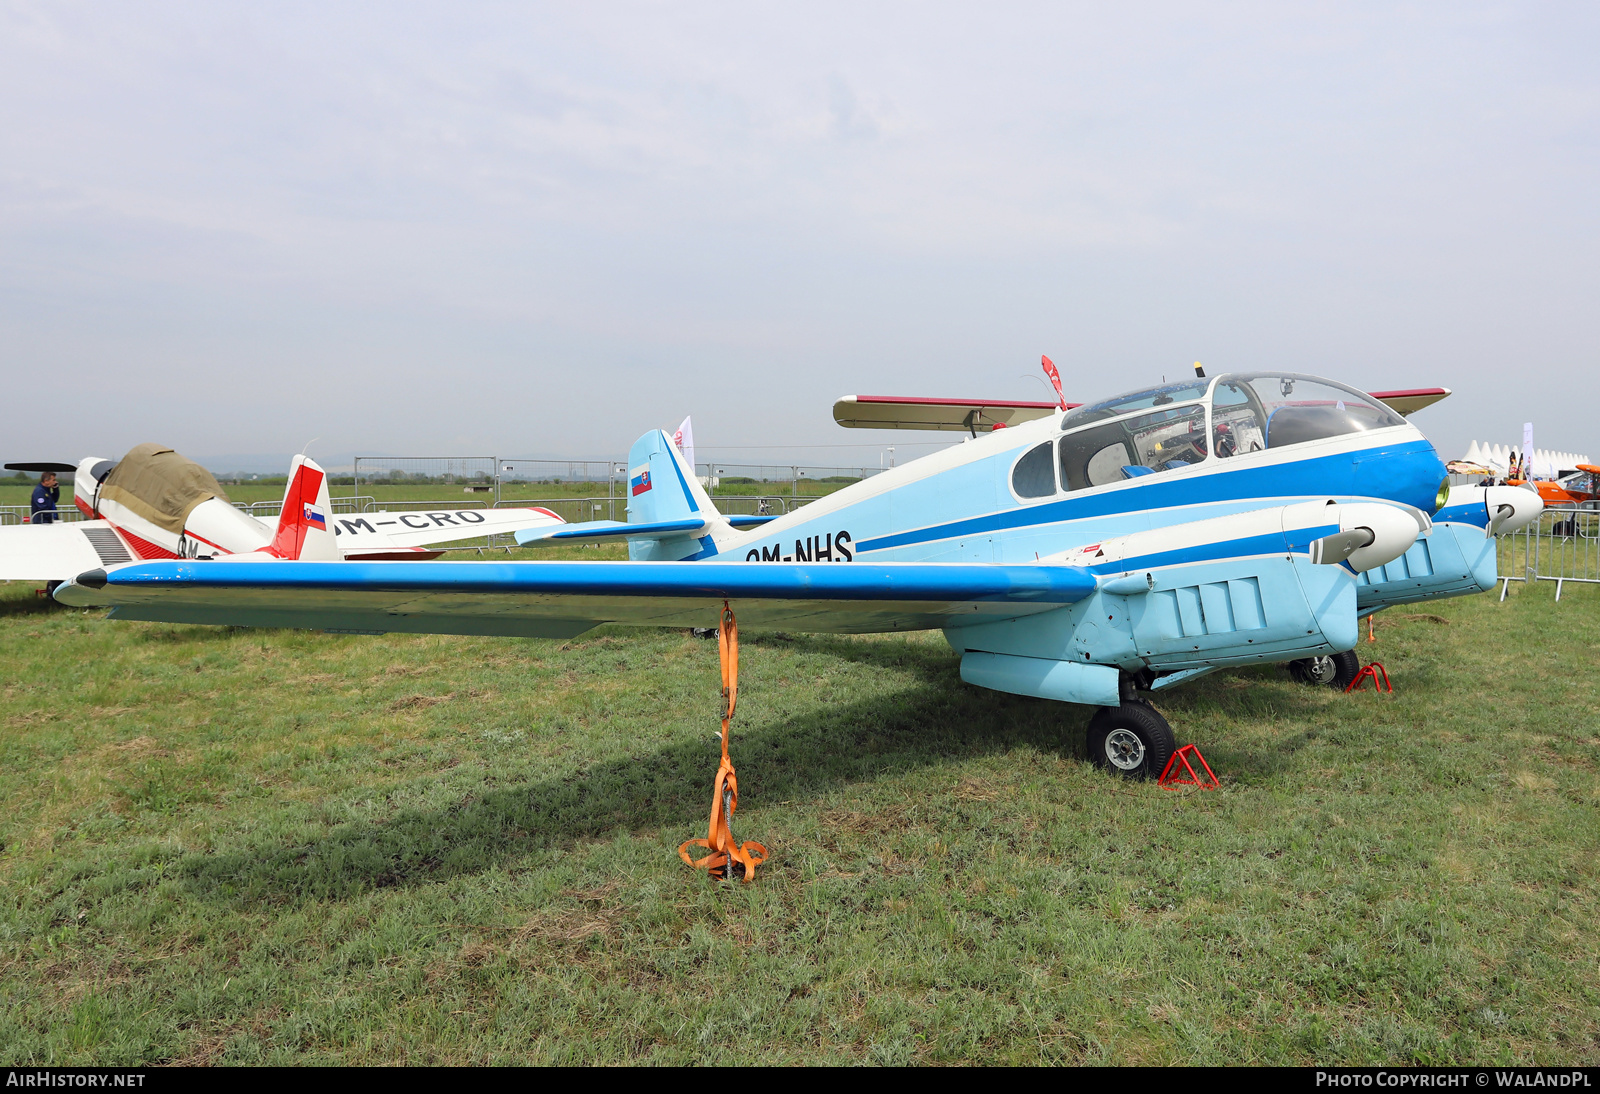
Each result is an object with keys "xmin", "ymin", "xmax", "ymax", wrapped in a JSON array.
[{"xmin": 944, "ymin": 502, "xmax": 1421, "ymax": 705}]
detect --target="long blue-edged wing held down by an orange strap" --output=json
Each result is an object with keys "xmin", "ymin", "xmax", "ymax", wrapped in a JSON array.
[{"xmin": 56, "ymin": 560, "xmax": 1094, "ymax": 638}]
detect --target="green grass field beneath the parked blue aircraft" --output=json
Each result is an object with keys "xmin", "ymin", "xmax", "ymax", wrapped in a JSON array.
[{"xmin": 0, "ymin": 572, "xmax": 1600, "ymax": 1065}]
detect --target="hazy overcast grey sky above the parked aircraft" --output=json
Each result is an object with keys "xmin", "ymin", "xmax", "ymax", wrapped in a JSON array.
[{"xmin": 0, "ymin": 0, "xmax": 1600, "ymax": 465}]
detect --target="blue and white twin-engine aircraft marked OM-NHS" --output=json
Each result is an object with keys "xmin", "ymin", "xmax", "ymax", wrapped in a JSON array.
[{"xmin": 56, "ymin": 373, "xmax": 1542, "ymax": 776}]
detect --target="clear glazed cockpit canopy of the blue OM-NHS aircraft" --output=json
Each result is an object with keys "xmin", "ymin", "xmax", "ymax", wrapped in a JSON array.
[{"xmin": 1011, "ymin": 373, "xmax": 1405, "ymax": 499}]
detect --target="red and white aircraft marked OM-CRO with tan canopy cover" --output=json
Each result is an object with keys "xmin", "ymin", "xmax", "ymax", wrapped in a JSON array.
[{"xmin": 0, "ymin": 445, "xmax": 562, "ymax": 582}]
